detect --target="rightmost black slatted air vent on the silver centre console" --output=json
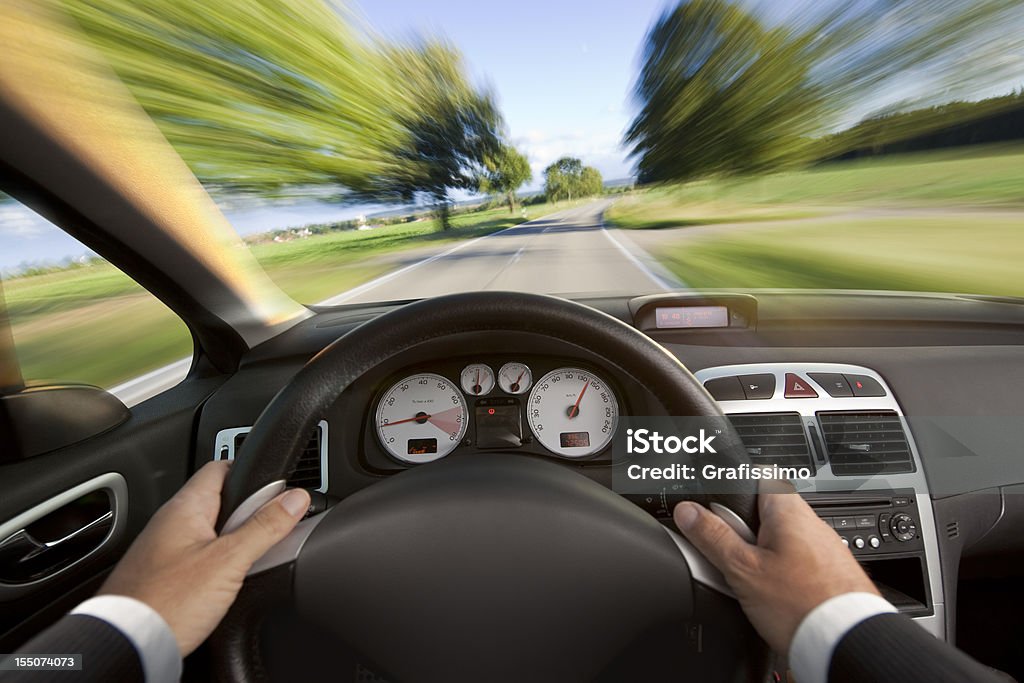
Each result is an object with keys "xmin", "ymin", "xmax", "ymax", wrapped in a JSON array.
[{"xmin": 818, "ymin": 411, "xmax": 913, "ymax": 476}]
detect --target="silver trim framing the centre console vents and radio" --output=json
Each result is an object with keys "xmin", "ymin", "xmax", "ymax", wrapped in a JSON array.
[{"xmin": 694, "ymin": 362, "xmax": 946, "ymax": 638}]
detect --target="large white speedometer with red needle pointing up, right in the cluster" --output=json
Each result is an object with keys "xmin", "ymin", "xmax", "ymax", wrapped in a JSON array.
[{"xmin": 527, "ymin": 368, "xmax": 618, "ymax": 458}]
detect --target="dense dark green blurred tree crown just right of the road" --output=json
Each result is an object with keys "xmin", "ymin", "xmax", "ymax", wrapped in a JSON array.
[{"xmin": 626, "ymin": 0, "xmax": 821, "ymax": 182}]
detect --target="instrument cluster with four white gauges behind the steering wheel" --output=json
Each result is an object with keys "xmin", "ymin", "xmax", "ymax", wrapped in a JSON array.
[{"xmin": 371, "ymin": 358, "xmax": 620, "ymax": 465}]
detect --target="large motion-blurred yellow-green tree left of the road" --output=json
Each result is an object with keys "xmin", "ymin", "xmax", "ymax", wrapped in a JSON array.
[{"xmin": 58, "ymin": 0, "xmax": 500, "ymax": 223}]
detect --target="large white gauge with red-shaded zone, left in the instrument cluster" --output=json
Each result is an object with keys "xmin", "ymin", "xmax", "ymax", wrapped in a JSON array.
[{"xmin": 377, "ymin": 373, "xmax": 469, "ymax": 465}]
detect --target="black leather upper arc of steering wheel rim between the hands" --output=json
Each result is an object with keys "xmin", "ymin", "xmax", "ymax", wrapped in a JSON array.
[{"xmin": 217, "ymin": 292, "xmax": 758, "ymax": 532}]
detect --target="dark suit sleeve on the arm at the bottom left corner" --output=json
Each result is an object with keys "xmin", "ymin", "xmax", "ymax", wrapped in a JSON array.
[{"xmin": 0, "ymin": 614, "xmax": 144, "ymax": 683}]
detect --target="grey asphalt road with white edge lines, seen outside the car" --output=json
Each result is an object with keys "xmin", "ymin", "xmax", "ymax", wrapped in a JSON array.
[{"xmin": 111, "ymin": 201, "xmax": 682, "ymax": 405}]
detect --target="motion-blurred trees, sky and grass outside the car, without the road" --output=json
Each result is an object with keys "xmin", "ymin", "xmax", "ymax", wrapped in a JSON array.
[{"xmin": 0, "ymin": 0, "xmax": 1024, "ymax": 395}]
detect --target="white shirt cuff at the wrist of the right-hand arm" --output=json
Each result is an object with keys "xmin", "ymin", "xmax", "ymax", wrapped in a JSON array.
[{"xmin": 790, "ymin": 593, "xmax": 896, "ymax": 683}]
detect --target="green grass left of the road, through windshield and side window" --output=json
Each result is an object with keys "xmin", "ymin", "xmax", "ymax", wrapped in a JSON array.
[{"xmin": 3, "ymin": 200, "xmax": 564, "ymax": 387}]
